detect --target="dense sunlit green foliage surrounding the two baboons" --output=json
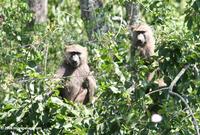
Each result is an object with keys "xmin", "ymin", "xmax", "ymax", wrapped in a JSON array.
[{"xmin": 0, "ymin": 0, "xmax": 200, "ymax": 135}]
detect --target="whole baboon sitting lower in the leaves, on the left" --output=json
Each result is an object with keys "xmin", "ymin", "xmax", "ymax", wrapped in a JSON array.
[{"xmin": 55, "ymin": 44, "xmax": 96, "ymax": 104}]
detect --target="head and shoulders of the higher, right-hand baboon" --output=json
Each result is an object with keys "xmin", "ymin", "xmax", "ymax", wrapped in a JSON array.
[{"xmin": 131, "ymin": 24, "xmax": 155, "ymax": 58}]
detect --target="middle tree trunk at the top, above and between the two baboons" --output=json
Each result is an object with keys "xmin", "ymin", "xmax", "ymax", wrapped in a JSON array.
[{"xmin": 79, "ymin": 0, "xmax": 103, "ymax": 40}]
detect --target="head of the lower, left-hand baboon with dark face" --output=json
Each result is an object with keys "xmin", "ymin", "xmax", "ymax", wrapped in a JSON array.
[{"xmin": 65, "ymin": 44, "xmax": 88, "ymax": 68}]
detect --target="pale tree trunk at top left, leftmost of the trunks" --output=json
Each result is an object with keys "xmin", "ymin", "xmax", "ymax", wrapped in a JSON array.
[{"xmin": 28, "ymin": 0, "xmax": 48, "ymax": 23}]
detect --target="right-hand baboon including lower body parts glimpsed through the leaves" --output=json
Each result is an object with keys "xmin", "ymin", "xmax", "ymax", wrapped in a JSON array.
[{"xmin": 131, "ymin": 24, "xmax": 166, "ymax": 113}]
